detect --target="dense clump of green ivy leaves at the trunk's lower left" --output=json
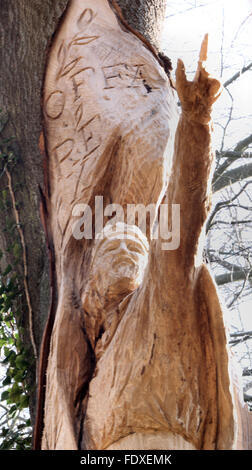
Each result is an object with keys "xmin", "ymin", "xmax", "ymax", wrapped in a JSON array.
[{"xmin": 0, "ymin": 266, "xmax": 31, "ymax": 450}]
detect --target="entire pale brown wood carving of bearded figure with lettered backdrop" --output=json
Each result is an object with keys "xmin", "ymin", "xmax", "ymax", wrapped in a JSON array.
[{"xmin": 34, "ymin": 0, "xmax": 244, "ymax": 449}]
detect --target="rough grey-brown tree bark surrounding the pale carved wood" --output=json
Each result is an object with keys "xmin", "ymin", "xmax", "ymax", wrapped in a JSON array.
[{"xmin": 0, "ymin": 0, "xmax": 166, "ymax": 430}]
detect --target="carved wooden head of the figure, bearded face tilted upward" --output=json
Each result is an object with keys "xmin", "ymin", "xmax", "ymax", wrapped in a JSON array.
[{"xmin": 82, "ymin": 222, "xmax": 149, "ymax": 348}]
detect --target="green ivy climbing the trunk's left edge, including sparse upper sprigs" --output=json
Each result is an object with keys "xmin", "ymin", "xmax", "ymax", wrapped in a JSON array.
[{"xmin": 0, "ymin": 115, "xmax": 32, "ymax": 450}]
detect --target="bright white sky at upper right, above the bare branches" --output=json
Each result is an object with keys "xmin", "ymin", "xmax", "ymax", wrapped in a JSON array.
[{"xmin": 163, "ymin": 0, "xmax": 252, "ymax": 148}]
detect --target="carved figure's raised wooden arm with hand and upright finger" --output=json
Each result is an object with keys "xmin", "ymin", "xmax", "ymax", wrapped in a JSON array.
[{"xmin": 163, "ymin": 35, "xmax": 220, "ymax": 270}]
